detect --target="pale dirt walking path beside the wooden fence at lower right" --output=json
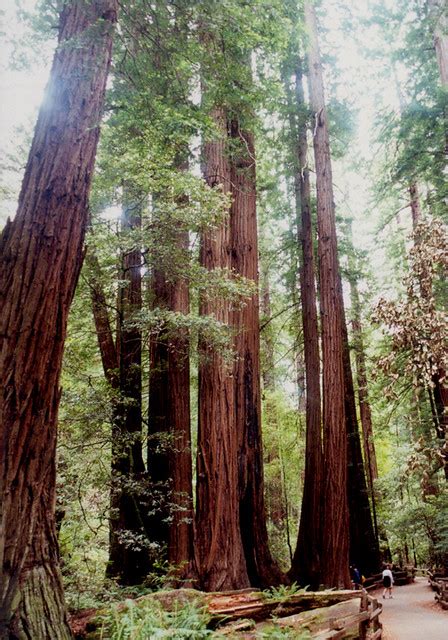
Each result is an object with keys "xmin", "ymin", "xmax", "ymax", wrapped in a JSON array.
[{"xmin": 375, "ymin": 578, "xmax": 448, "ymax": 640}]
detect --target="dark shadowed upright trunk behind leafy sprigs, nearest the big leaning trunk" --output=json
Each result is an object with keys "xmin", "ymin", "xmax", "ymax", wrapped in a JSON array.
[{"xmin": 106, "ymin": 194, "xmax": 150, "ymax": 585}]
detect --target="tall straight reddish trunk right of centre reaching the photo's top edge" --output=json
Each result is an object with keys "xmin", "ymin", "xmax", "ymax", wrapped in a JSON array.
[{"xmin": 305, "ymin": 1, "xmax": 350, "ymax": 587}]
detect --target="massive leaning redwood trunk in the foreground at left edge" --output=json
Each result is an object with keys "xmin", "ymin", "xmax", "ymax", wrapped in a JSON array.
[{"xmin": 0, "ymin": 0, "xmax": 117, "ymax": 640}]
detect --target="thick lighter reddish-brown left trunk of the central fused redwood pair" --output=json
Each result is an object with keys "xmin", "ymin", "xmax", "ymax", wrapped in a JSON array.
[{"xmin": 196, "ymin": 108, "xmax": 249, "ymax": 591}]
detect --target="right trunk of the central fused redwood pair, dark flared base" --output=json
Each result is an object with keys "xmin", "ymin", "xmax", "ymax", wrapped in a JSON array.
[{"xmin": 230, "ymin": 120, "xmax": 283, "ymax": 587}]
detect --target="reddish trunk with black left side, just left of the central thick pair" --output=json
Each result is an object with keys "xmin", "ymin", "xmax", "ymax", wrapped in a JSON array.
[{"xmin": 148, "ymin": 221, "xmax": 194, "ymax": 572}]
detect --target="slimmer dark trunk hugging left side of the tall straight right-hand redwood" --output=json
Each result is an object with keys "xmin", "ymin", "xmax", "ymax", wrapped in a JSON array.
[{"xmin": 290, "ymin": 69, "xmax": 323, "ymax": 589}]
